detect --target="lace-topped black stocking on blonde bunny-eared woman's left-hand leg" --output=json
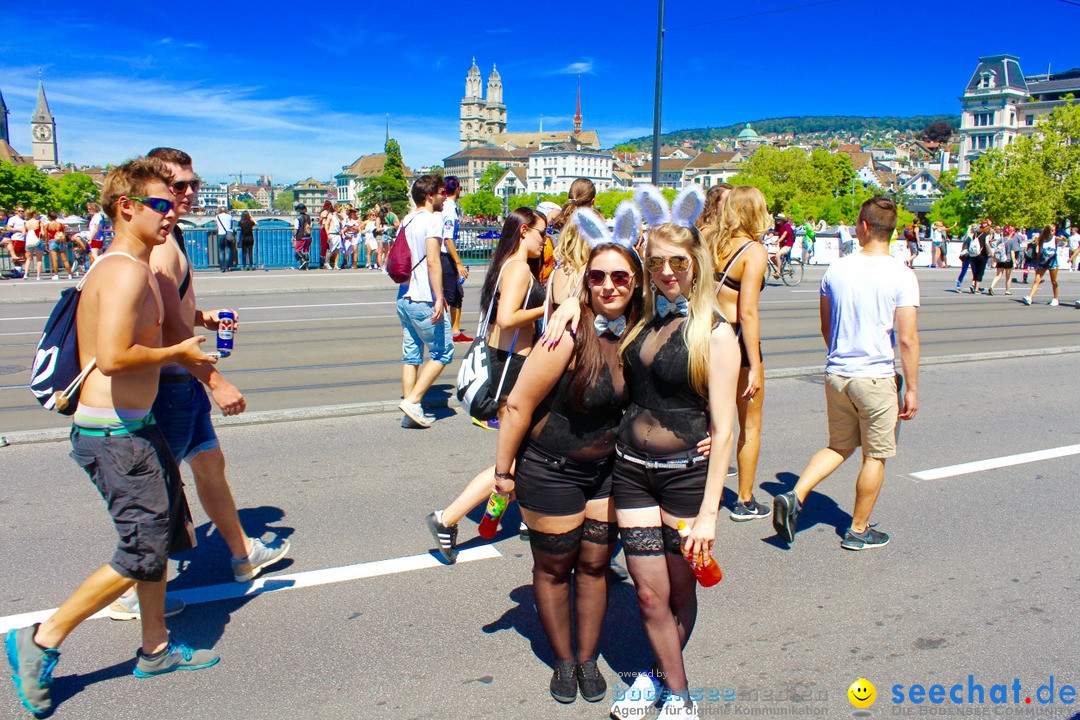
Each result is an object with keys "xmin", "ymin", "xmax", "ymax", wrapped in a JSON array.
[{"xmin": 619, "ymin": 527, "xmax": 687, "ymax": 691}]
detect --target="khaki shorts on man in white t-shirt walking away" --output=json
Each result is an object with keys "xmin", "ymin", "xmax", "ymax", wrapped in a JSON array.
[{"xmin": 825, "ymin": 372, "xmax": 900, "ymax": 458}]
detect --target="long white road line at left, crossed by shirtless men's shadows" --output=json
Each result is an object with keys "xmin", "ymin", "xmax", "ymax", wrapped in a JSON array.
[{"xmin": 0, "ymin": 545, "xmax": 502, "ymax": 633}]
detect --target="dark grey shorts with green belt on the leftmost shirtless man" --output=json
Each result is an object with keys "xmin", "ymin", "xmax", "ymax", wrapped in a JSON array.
[{"xmin": 71, "ymin": 425, "xmax": 194, "ymax": 582}]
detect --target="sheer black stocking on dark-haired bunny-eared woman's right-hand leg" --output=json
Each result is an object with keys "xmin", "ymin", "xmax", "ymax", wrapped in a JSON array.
[{"xmin": 573, "ymin": 518, "xmax": 619, "ymax": 663}]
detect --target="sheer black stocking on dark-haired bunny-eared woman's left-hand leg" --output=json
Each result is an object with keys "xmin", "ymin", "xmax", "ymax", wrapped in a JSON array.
[{"xmin": 529, "ymin": 526, "xmax": 581, "ymax": 662}]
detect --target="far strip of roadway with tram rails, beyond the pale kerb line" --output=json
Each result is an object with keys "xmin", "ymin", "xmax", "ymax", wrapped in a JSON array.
[{"xmin": 0, "ymin": 268, "xmax": 1080, "ymax": 435}]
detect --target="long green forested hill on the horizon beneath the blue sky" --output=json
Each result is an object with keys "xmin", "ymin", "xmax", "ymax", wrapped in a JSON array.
[{"xmin": 626, "ymin": 116, "xmax": 960, "ymax": 149}]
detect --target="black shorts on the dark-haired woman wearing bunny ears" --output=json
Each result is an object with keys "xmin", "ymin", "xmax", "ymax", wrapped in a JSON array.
[{"xmin": 514, "ymin": 443, "xmax": 615, "ymax": 515}]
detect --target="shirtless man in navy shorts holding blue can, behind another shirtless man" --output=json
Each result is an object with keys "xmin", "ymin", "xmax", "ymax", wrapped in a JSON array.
[{"xmin": 137, "ymin": 148, "xmax": 288, "ymax": 595}]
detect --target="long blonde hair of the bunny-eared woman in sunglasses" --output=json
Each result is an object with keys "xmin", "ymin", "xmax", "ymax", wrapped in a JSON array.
[{"xmin": 619, "ymin": 222, "xmax": 723, "ymax": 399}]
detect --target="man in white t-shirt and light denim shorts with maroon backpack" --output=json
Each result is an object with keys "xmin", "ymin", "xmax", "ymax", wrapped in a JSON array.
[{"xmin": 397, "ymin": 175, "xmax": 454, "ymax": 427}]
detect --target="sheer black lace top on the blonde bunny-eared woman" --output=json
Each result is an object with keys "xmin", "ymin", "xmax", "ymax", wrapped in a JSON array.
[{"xmin": 619, "ymin": 314, "xmax": 708, "ymax": 454}]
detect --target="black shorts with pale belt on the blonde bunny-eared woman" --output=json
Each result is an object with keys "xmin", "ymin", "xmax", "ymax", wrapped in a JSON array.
[{"xmin": 611, "ymin": 445, "xmax": 708, "ymax": 517}]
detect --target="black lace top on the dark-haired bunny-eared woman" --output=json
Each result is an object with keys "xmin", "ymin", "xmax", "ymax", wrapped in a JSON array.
[{"xmin": 529, "ymin": 339, "xmax": 626, "ymax": 461}]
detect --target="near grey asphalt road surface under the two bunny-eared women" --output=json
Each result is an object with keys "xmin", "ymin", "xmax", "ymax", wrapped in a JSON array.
[{"xmin": 0, "ymin": 354, "xmax": 1080, "ymax": 720}]
